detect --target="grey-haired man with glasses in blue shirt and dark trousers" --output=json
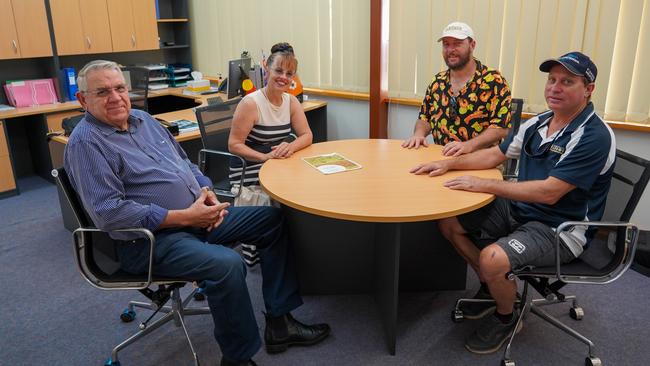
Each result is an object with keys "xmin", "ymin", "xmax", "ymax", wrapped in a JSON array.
[{"xmin": 64, "ymin": 60, "xmax": 330, "ymax": 366}]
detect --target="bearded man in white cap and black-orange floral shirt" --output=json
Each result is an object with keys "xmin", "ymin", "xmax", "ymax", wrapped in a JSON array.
[{"xmin": 402, "ymin": 22, "xmax": 510, "ymax": 156}]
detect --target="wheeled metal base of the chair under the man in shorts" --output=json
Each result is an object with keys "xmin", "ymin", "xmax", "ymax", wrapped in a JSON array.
[{"xmin": 452, "ymin": 281, "xmax": 602, "ymax": 366}]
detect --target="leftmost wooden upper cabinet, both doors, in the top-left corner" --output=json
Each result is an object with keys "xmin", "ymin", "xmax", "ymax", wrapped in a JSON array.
[{"xmin": 0, "ymin": 0, "xmax": 52, "ymax": 59}]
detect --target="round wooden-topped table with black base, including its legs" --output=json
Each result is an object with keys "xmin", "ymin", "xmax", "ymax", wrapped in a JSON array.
[{"xmin": 260, "ymin": 140, "xmax": 501, "ymax": 354}]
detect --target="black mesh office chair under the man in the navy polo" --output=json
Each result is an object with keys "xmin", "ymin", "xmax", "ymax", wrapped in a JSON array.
[{"xmin": 451, "ymin": 150, "xmax": 650, "ymax": 366}]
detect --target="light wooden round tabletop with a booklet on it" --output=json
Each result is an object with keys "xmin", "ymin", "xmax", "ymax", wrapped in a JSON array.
[{"xmin": 260, "ymin": 140, "xmax": 501, "ymax": 222}]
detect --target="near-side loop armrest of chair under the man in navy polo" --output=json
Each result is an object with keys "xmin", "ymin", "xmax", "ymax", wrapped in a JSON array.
[{"xmin": 555, "ymin": 221, "xmax": 639, "ymax": 284}]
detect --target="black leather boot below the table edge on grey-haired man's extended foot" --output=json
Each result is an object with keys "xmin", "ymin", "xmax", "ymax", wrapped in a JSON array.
[{"xmin": 264, "ymin": 313, "xmax": 330, "ymax": 353}]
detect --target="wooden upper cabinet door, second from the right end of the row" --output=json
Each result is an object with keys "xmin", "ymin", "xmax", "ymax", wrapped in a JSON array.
[{"xmin": 106, "ymin": 0, "xmax": 139, "ymax": 52}]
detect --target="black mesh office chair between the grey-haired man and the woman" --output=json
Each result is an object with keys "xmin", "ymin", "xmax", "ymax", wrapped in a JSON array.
[{"xmin": 194, "ymin": 98, "xmax": 246, "ymax": 203}]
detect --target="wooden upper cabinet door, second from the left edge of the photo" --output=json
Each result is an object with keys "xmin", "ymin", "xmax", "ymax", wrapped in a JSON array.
[{"xmin": 11, "ymin": 0, "xmax": 52, "ymax": 58}]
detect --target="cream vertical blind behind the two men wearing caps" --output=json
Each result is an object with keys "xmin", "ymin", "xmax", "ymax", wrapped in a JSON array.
[{"xmin": 389, "ymin": 0, "xmax": 650, "ymax": 123}]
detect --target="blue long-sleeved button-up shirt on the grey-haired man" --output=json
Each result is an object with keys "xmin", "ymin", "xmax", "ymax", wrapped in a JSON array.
[{"xmin": 64, "ymin": 110, "xmax": 212, "ymax": 231}]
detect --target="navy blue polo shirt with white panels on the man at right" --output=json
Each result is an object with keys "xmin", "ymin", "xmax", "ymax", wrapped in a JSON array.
[{"xmin": 499, "ymin": 103, "xmax": 616, "ymax": 254}]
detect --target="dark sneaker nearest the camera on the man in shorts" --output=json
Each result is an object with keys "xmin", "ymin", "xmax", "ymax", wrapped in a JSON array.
[{"xmin": 465, "ymin": 309, "xmax": 523, "ymax": 354}]
